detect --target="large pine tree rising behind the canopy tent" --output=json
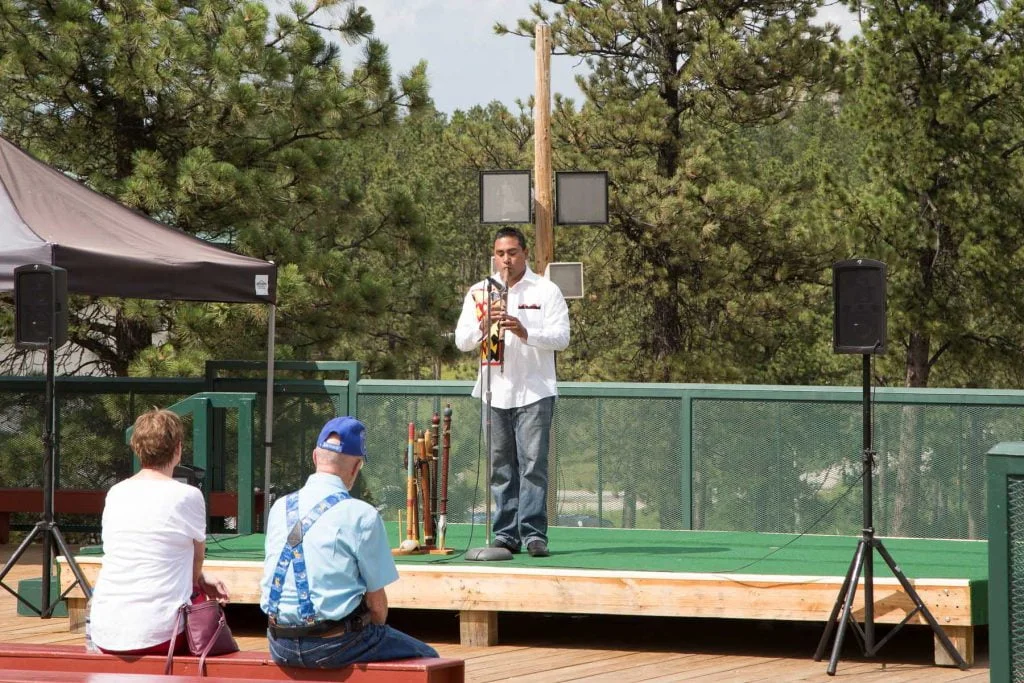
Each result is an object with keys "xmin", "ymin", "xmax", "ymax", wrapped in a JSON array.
[{"xmin": 0, "ymin": 0, "xmax": 426, "ymax": 375}]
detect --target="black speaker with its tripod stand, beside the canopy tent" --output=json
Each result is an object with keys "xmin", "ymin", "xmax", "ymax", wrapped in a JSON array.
[{"xmin": 0, "ymin": 263, "xmax": 92, "ymax": 618}]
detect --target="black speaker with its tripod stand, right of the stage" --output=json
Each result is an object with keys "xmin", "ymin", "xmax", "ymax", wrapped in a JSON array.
[{"xmin": 814, "ymin": 259, "xmax": 968, "ymax": 676}]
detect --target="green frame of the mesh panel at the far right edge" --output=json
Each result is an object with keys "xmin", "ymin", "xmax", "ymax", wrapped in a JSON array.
[{"xmin": 985, "ymin": 441, "xmax": 1024, "ymax": 681}]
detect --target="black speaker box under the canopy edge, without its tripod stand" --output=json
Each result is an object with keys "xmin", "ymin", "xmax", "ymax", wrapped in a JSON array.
[{"xmin": 14, "ymin": 263, "xmax": 68, "ymax": 349}]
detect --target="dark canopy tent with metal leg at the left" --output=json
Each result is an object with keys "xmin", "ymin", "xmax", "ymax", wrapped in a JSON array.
[{"xmin": 0, "ymin": 137, "xmax": 278, "ymax": 518}]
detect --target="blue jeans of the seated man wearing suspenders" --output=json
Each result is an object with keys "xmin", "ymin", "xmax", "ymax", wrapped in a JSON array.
[{"xmin": 266, "ymin": 624, "xmax": 437, "ymax": 669}]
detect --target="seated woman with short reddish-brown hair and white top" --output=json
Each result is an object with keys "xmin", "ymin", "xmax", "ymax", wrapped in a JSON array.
[{"xmin": 89, "ymin": 409, "xmax": 228, "ymax": 654}]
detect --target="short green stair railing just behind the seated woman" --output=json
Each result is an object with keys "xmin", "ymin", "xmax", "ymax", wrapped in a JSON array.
[{"xmin": 125, "ymin": 392, "xmax": 256, "ymax": 533}]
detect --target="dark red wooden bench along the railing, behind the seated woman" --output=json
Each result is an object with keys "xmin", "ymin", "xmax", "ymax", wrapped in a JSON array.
[{"xmin": 0, "ymin": 488, "xmax": 263, "ymax": 545}]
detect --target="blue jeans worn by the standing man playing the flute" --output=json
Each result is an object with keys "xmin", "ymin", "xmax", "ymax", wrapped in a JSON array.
[{"xmin": 490, "ymin": 396, "xmax": 555, "ymax": 546}]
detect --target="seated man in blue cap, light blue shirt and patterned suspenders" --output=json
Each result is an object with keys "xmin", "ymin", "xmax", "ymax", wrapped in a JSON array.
[{"xmin": 260, "ymin": 417, "xmax": 437, "ymax": 669}]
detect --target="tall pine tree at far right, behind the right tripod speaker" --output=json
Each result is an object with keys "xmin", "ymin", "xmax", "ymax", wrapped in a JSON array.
[{"xmin": 842, "ymin": 0, "xmax": 1024, "ymax": 386}]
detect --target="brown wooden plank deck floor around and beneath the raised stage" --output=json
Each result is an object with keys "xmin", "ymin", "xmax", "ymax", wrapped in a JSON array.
[{"xmin": 0, "ymin": 546, "xmax": 988, "ymax": 683}]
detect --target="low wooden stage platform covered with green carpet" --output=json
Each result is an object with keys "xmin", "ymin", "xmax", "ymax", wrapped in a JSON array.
[{"xmin": 60, "ymin": 524, "xmax": 988, "ymax": 665}]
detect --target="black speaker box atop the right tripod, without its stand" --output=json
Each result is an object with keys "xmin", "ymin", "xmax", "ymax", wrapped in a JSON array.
[{"xmin": 833, "ymin": 258, "xmax": 886, "ymax": 354}]
